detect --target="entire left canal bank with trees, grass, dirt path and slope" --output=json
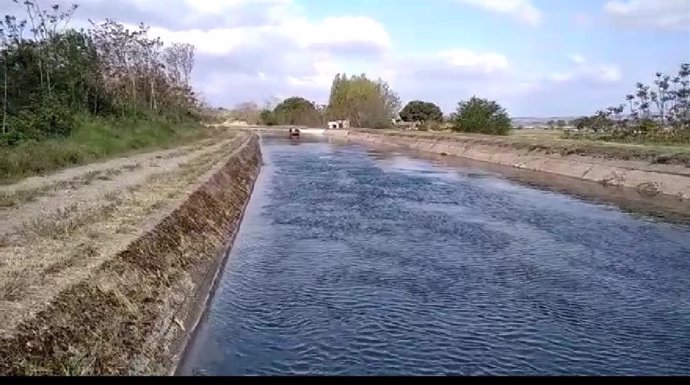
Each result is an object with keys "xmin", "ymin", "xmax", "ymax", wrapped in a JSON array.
[{"xmin": 0, "ymin": 0, "xmax": 261, "ymax": 375}]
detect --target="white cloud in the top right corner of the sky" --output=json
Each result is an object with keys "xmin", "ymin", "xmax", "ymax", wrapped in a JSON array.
[{"xmin": 604, "ymin": 0, "xmax": 690, "ymax": 31}]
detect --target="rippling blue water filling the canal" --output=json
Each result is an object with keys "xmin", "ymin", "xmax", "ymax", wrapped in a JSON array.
[{"xmin": 180, "ymin": 137, "xmax": 690, "ymax": 375}]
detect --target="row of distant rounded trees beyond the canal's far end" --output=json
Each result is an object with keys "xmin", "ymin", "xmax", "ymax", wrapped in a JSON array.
[{"xmin": 229, "ymin": 74, "xmax": 511, "ymax": 135}]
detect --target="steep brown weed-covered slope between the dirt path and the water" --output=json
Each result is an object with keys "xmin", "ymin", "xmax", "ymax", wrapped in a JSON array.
[{"xmin": 0, "ymin": 134, "xmax": 262, "ymax": 375}]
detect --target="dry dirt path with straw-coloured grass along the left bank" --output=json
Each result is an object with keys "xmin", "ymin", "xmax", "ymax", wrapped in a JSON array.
[{"xmin": 0, "ymin": 131, "xmax": 248, "ymax": 334}]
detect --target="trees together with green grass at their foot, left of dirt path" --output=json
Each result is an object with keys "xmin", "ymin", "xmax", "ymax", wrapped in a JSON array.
[{"xmin": 0, "ymin": 0, "xmax": 219, "ymax": 184}]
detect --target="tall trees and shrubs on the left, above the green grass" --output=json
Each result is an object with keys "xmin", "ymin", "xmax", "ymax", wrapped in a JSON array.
[{"xmin": 0, "ymin": 0, "xmax": 200, "ymax": 146}]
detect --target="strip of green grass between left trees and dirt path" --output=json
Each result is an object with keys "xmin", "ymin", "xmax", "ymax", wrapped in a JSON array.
[{"xmin": 0, "ymin": 116, "xmax": 209, "ymax": 184}]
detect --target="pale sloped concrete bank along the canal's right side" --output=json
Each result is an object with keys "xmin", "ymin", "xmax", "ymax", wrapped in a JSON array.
[{"xmin": 326, "ymin": 130, "xmax": 690, "ymax": 199}]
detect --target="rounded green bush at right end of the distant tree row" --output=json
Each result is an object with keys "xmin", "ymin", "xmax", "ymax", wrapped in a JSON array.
[{"xmin": 452, "ymin": 96, "xmax": 511, "ymax": 135}]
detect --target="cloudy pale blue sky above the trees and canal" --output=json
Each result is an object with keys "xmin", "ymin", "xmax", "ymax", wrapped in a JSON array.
[{"xmin": 0, "ymin": 0, "xmax": 690, "ymax": 117}]
